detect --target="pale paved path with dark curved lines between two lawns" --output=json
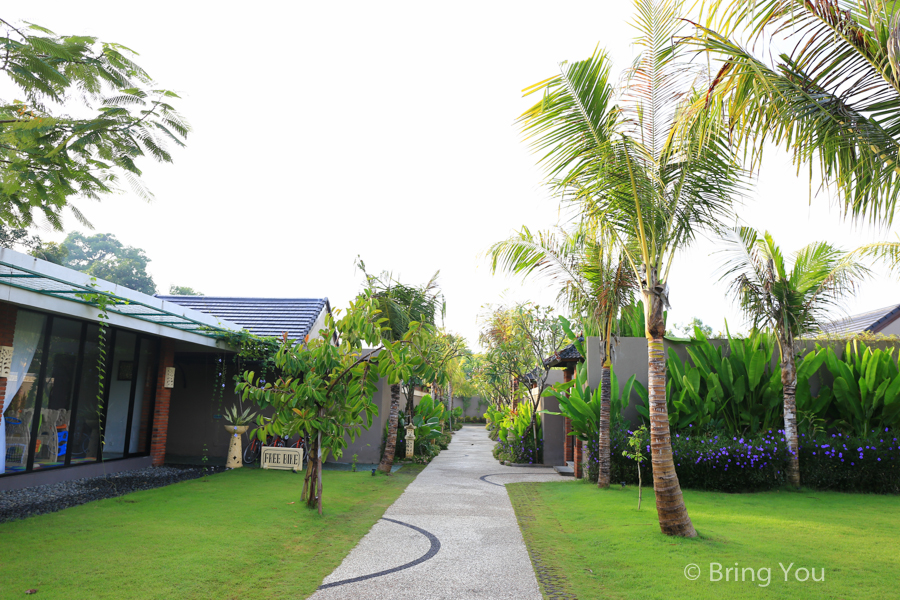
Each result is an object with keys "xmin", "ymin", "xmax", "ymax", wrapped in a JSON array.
[{"xmin": 312, "ymin": 425, "xmax": 562, "ymax": 600}]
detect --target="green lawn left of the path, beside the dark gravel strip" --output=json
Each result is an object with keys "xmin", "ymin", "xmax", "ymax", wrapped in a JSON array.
[{"xmin": 0, "ymin": 465, "xmax": 423, "ymax": 600}]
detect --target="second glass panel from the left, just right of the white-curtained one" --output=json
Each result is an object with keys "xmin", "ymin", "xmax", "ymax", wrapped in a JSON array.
[{"xmin": 34, "ymin": 317, "xmax": 81, "ymax": 469}]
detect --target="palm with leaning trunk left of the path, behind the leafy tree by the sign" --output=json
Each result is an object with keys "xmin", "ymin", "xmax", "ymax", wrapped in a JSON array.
[{"xmin": 358, "ymin": 261, "xmax": 443, "ymax": 474}]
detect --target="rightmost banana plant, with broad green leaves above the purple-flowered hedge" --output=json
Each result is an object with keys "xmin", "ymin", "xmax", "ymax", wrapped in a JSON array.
[{"xmin": 824, "ymin": 340, "xmax": 900, "ymax": 437}]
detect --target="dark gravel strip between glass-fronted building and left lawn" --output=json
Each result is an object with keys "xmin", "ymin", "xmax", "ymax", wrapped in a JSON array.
[{"xmin": 0, "ymin": 466, "xmax": 225, "ymax": 523}]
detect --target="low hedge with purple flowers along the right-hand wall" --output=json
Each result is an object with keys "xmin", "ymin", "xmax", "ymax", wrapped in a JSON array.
[{"xmin": 604, "ymin": 427, "xmax": 900, "ymax": 494}]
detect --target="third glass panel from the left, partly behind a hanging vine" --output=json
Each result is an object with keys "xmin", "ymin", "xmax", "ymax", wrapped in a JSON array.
[{"xmin": 69, "ymin": 323, "xmax": 102, "ymax": 465}]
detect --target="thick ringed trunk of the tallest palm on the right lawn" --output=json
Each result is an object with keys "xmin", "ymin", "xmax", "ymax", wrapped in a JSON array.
[{"xmin": 644, "ymin": 292, "xmax": 697, "ymax": 537}]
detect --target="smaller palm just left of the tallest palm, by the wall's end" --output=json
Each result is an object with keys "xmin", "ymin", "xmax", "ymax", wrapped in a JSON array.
[{"xmin": 489, "ymin": 221, "xmax": 635, "ymax": 488}]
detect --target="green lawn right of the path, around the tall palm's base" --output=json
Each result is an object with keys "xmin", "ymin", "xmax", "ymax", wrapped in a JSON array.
[{"xmin": 506, "ymin": 482, "xmax": 900, "ymax": 600}]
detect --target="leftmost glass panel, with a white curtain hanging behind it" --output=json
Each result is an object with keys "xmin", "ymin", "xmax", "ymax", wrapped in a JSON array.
[{"xmin": 0, "ymin": 310, "xmax": 47, "ymax": 474}]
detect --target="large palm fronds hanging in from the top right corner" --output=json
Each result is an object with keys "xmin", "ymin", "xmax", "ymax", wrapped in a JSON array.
[{"xmin": 684, "ymin": 0, "xmax": 900, "ymax": 223}]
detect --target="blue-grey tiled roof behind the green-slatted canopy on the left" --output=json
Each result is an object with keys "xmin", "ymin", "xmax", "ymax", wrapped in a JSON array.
[{"xmin": 157, "ymin": 296, "xmax": 330, "ymax": 340}]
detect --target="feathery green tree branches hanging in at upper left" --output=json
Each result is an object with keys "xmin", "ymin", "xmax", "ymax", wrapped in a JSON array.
[{"xmin": 0, "ymin": 18, "xmax": 190, "ymax": 229}]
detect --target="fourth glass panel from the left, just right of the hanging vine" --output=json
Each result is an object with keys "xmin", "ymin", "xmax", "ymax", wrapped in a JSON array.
[{"xmin": 103, "ymin": 331, "xmax": 137, "ymax": 460}]
